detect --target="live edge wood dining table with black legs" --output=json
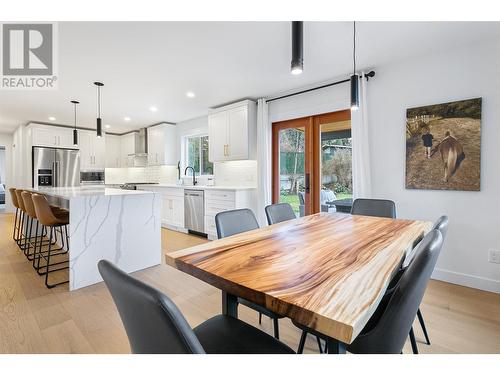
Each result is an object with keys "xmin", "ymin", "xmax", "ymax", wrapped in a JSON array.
[{"xmin": 166, "ymin": 213, "xmax": 432, "ymax": 353}]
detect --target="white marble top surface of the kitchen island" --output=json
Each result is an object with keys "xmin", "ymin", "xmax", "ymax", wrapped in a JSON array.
[{"xmin": 25, "ymin": 186, "xmax": 153, "ymax": 200}]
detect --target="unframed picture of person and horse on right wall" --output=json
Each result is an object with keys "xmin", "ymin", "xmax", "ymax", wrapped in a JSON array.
[{"xmin": 406, "ymin": 98, "xmax": 482, "ymax": 191}]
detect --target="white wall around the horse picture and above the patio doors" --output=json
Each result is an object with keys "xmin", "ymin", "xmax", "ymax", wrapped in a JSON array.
[{"xmin": 269, "ymin": 36, "xmax": 500, "ymax": 293}]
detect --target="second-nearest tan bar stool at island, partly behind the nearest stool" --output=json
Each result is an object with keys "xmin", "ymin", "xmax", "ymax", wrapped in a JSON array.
[{"xmin": 21, "ymin": 191, "xmax": 67, "ymax": 275}]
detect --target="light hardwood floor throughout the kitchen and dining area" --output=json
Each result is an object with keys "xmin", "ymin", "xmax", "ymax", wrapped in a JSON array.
[{"xmin": 0, "ymin": 214, "xmax": 500, "ymax": 353}]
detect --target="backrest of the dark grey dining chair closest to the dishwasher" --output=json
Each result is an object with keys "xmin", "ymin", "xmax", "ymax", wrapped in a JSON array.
[{"xmin": 215, "ymin": 208, "xmax": 259, "ymax": 238}]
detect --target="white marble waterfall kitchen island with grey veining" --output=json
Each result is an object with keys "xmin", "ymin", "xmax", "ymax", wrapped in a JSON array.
[{"xmin": 26, "ymin": 187, "xmax": 161, "ymax": 290}]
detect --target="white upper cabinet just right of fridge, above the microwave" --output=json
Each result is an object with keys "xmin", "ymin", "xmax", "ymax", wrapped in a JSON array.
[{"xmin": 78, "ymin": 130, "xmax": 106, "ymax": 170}]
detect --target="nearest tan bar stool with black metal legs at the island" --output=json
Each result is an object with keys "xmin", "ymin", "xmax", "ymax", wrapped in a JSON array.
[{"xmin": 31, "ymin": 194, "xmax": 69, "ymax": 288}]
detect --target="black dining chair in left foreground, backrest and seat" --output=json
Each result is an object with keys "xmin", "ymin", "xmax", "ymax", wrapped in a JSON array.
[{"xmin": 98, "ymin": 260, "xmax": 294, "ymax": 354}]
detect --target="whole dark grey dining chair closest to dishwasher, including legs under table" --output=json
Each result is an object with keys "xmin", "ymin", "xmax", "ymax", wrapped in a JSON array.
[{"xmin": 215, "ymin": 208, "xmax": 283, "ymax": 340}]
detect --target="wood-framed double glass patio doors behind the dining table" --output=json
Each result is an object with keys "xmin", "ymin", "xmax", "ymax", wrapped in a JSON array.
[{"xmin": 273, "ymin": 111, "xmax": 352, "ymax": 216}]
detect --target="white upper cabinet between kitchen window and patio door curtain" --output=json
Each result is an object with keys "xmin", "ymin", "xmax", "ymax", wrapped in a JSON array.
[{"xmin": 208, "ymin": 100, "xmax": 257, "ymax": 162}]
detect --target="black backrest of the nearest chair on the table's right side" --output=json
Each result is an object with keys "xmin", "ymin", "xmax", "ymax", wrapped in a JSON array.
[{"xmin": 348, "ymin": 230, "xmax": 443, "ymax": 354}]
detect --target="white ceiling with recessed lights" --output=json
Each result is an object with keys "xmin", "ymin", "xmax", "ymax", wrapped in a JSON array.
[{"xmin": 0, "ymin": 22, "xmax": 500, "ymax": 133}]
